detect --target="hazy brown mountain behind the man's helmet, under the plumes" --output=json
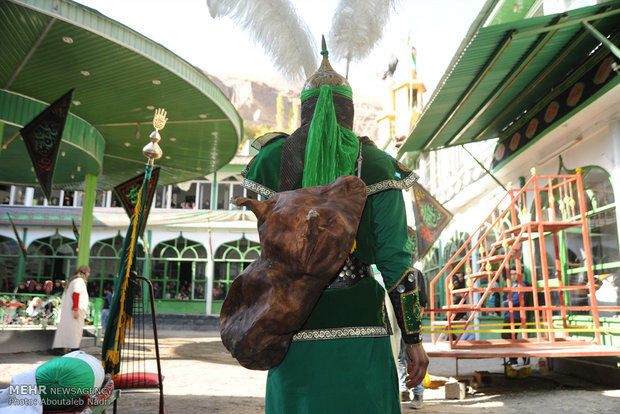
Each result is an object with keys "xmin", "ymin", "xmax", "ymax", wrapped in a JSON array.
[{"xmin": 207, "ymin": 74, "xmax": 382, "ymax": 139}]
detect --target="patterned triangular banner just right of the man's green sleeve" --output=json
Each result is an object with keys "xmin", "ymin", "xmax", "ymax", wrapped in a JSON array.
[{"xmin": 413, "ymin": 182, "xmax": 452, "ymax": 260}]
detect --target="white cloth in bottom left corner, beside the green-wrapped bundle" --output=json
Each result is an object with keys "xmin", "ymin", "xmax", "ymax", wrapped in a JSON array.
[{"xmin": 0, "ymin": 369, "xmax": 43, "ymax": 414}]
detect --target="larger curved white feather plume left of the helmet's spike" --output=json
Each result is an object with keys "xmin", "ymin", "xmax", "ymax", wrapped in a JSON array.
[{"xmin": 207, "ymin": 0, "xmax": 319, "ymax": 81}]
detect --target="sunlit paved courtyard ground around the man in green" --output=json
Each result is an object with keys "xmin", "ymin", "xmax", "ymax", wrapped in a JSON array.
[{"xmin": 0, "ymin": 331, "xmax": 620, "ymax": 414}]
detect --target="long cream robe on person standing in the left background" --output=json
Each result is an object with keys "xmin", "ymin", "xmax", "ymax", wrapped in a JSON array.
[{"xmin": 52, "ymin": 277, "xmax": 88, "ymax": 348}]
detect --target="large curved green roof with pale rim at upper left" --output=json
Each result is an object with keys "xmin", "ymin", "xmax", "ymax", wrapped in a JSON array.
[{"xmin": 0, "ymin": 0, "xmax": 243, "ymax": 189}]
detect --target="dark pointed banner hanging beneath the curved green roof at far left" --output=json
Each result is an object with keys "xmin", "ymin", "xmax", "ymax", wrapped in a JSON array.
[{"xmin": 19, "ymin": 89, "xmax": 73, "ymax": 201}]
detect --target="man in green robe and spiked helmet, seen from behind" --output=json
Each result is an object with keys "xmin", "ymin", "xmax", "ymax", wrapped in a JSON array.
[{"xmin": 243, "ymin": 40, "xmax": 428, "ymax": 414}]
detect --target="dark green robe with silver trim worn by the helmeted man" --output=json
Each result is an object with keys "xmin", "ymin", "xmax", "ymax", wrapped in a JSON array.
[{"xmin": 243, "ymin": 138, "xmax": 417, "ymax": 414}]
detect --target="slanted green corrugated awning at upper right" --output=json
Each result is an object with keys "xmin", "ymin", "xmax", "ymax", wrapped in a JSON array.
[{"xmin": 399, "ymin": 0, "xmax": 620, "ymax": 155}]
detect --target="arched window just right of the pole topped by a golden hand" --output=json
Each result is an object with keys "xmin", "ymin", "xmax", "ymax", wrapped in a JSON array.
[{"xmin": 151, "ymin": 236, "xmax": 207, "ymax": 300}]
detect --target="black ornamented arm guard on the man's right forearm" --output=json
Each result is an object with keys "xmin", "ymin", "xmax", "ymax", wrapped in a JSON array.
[{"xmin": 388, "ymin": 269, "xmax": 426, "ymax": 344}]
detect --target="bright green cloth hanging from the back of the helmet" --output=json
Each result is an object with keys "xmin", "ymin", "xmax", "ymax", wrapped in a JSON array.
[{"xmin": 301, "ymin": 85, "xmax": 359, "ymax": 187}]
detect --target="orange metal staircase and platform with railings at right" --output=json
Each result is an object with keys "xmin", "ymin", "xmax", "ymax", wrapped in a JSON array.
[{"xmin": 426, "ymin": 171, "xmax": 620, "ymax": 358}]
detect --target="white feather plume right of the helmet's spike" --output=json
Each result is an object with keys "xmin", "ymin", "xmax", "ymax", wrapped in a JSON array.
[{"xmin": 327, "ymin": 0, "xmax": 395, "ymax": 61}]
